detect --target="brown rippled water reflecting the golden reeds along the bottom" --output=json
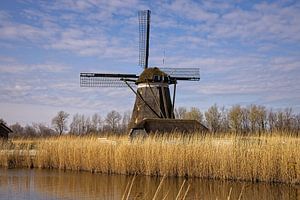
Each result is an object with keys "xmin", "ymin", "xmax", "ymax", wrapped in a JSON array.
[{"xmin": 0, "ymin": 169, "xmax": 300, "ymax": 200}]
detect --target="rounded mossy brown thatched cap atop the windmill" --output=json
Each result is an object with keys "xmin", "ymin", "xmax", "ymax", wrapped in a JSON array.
[{"xmin": 136, "ymin": 67, "xmax": 169, "ymax": 84}]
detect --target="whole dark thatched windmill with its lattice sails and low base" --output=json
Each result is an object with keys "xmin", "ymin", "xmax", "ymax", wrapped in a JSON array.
[{"xmin": 80, "ymin": 10, "xmax": 207, "ymax": 135}]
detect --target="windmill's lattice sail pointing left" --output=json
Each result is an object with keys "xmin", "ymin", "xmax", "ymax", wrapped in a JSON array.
[{"xmin": 80, "ymin": 73, "xmax": 138, "ymax": 87}]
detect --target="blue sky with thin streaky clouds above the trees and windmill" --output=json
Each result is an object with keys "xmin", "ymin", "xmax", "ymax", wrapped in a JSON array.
[{"xmin": 0, "ymin": 0, "xmax": 300, "ymax": 124}]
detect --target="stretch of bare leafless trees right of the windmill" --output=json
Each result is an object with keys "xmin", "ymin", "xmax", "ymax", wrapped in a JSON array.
[{"xmin": 175, "ymin": 104, "xmax": 300, "ymax": 135}]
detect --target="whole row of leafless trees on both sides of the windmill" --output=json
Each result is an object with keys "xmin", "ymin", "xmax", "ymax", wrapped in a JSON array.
[{"xmin": 0, "ymin": 104, "xmax": 300, "ymax": 137}]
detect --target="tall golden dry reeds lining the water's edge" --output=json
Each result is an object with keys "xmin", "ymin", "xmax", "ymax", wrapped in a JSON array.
[{"xmin": 0, "ymin": 135, "xmax": 300, "ymax": 184}]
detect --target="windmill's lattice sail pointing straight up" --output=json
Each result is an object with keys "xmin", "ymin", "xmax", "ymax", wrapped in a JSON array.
[{"xmin": 139, "ymin": 10, "xmax": 151, "ymax": 69}]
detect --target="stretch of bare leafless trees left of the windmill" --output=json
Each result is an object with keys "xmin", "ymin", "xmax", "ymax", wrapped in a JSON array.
[{"xmin": 0, "ymin": 110, "xmax": 130, "ymax": 137}]
